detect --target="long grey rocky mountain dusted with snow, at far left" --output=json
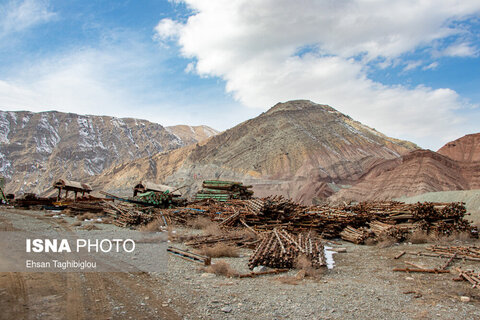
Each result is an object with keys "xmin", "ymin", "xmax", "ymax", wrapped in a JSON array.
[{"xmin": 0, "ymin": 111, "xmax": 215, "ymax": 193}]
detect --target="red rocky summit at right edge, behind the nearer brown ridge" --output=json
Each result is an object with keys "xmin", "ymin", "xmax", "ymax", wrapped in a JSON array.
[{"xmin": 437, "ymin": 133, "xmax": 480, "ymax": 162}]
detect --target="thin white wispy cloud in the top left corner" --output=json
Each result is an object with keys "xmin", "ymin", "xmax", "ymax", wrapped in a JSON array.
[{"xmin": 0, "ymin": 0, "xmax": 55, "ymax": 37}]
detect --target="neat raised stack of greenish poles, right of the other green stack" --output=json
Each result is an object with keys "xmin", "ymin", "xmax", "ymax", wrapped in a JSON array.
[{"xmin": 195, "ymin": 180, "xmax": 253, "ymax": 201}]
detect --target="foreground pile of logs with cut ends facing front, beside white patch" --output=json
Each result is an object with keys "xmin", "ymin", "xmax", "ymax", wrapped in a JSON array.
[{"xmin": 248, "ymin": 229, "xmax": 326, "ymax": 269}]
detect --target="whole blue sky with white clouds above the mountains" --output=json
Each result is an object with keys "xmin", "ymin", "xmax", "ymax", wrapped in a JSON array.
[{"xmin": 0, "ymin": 0, "xmax": 480, "ymax": 150}]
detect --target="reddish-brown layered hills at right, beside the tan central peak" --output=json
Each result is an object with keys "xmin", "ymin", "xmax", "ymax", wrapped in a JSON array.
[{"xmin": 330, "ymin": 134, "xmax": 480, "ymax": 201}]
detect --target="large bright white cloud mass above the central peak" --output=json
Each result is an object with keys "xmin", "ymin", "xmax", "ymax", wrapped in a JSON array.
[{"xmin": 157, "ymin": 0, "xmax": 480, "ymax": 145}]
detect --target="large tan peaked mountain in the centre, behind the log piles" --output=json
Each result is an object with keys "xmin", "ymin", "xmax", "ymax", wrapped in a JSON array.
[{"xmin": 95, "ymin": 100, "xmax": 418, "ymax": 203}]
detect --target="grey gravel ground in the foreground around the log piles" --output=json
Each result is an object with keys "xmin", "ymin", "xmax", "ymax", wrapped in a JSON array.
[{"xmin": 0, "ymin": 210, "xmax": 480, "ymax": 319}]
